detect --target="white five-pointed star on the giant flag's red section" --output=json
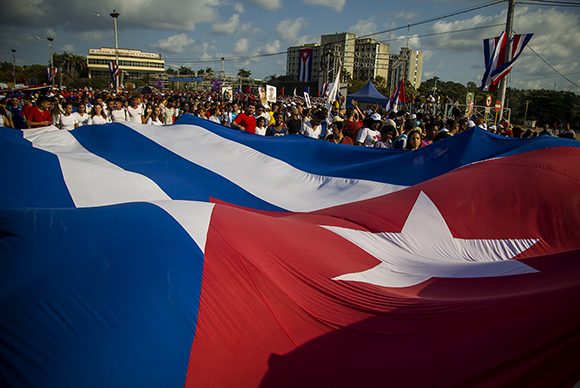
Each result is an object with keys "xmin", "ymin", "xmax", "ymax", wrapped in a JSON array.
[{"xmin": 324, "ymin": 192, "xmax": 538, "ymax": 287}]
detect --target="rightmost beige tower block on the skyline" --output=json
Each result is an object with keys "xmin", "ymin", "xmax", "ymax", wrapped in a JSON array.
[{"xmin": 388, "ymin": 47, "xmax": 423, "ymax": 92}]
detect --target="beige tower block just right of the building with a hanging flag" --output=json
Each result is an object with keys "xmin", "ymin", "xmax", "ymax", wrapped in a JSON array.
[{"xmin": 352, "ymin": 38, "xmax": 390, "ymax": 81}]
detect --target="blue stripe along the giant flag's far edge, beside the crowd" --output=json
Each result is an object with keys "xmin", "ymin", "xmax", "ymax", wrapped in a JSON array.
[{"xmin": 178, "ymin": 115, "xmax": 579, "ymax": 186}]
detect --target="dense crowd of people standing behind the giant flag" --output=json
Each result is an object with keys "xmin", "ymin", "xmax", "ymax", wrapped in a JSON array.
[{"xmin": 0, "ymin": 89, "xmax": 576, "ymax": 150}]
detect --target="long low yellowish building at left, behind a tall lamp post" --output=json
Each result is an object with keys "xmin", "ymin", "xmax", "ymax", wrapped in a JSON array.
[{"xmin": 87, "ymin": 47, "xmax": 165, "ymax": 80}]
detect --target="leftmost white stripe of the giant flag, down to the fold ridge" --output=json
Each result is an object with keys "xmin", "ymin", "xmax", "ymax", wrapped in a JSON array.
[{"xmin": 23, "ymin": 127, "xmax": 171, "ymax": 207}]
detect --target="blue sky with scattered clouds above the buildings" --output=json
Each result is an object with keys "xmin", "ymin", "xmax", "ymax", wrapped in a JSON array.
[{"xmin": 0, "ymin": 0, "xmax": 580, "ymax": 93}]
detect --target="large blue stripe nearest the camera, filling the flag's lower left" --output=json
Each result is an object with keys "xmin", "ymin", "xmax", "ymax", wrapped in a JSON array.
[{"xmin": 0, "ymin": 203, "xmax": 203, "ymax": 387}]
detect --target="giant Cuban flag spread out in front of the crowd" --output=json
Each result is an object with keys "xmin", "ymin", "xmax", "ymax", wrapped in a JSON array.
[{"xmin": 0, "ymin": 117, "xmax": 580, "ymax": 387}]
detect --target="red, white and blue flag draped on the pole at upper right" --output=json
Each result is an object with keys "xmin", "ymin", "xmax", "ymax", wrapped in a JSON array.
[{"xmin": 481, "ymin": 32, "xmax": 534, "ymax": 91}]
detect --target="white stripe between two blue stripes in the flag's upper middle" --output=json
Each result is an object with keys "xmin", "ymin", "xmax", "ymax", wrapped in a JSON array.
[{"xmin": 123, "ymin": 123, "xmax": 406, "ymax": 212}]
